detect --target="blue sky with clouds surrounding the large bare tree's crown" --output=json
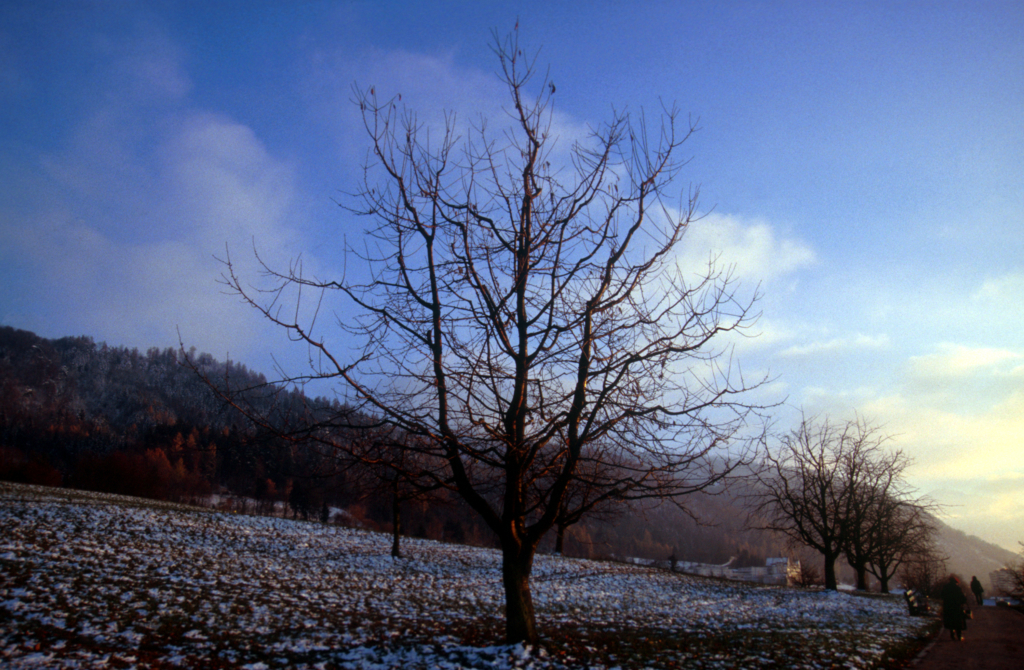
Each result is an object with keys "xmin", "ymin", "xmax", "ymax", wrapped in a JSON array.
[{"xmin": 0, "ymin": 0, "xmax": 1024, "ymax": 550}]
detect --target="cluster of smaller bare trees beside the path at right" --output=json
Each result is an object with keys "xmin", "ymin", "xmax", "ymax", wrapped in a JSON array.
[{"xmin": 750, "ymin": 417, "xmax": 938, "ymax": 592}]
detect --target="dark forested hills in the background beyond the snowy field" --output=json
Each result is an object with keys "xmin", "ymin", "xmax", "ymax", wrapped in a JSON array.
[{"xmin": 0, "ymin": 327, "xmax": 1016, "ymax": 589}]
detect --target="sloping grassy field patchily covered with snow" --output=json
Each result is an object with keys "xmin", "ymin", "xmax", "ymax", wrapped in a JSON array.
[{"xmin": 0, "ymin": 483, "xmax": 932, "ymax": 669}]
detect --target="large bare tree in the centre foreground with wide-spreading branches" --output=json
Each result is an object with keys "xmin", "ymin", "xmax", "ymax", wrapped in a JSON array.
[{"xmin": 211, "ymin": 27, "xmax": 763, "ymax": 642}]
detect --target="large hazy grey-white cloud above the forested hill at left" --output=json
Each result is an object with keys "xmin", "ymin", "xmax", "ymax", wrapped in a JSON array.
[{"xmin": 0, "ymin": 22, "xmax": 311, "ymax": 364}]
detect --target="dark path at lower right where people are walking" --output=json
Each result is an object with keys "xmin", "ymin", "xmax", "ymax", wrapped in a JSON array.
[{"xmin": 913, "ymin": 605, "xmax": 1024, "ymax": 670}]
